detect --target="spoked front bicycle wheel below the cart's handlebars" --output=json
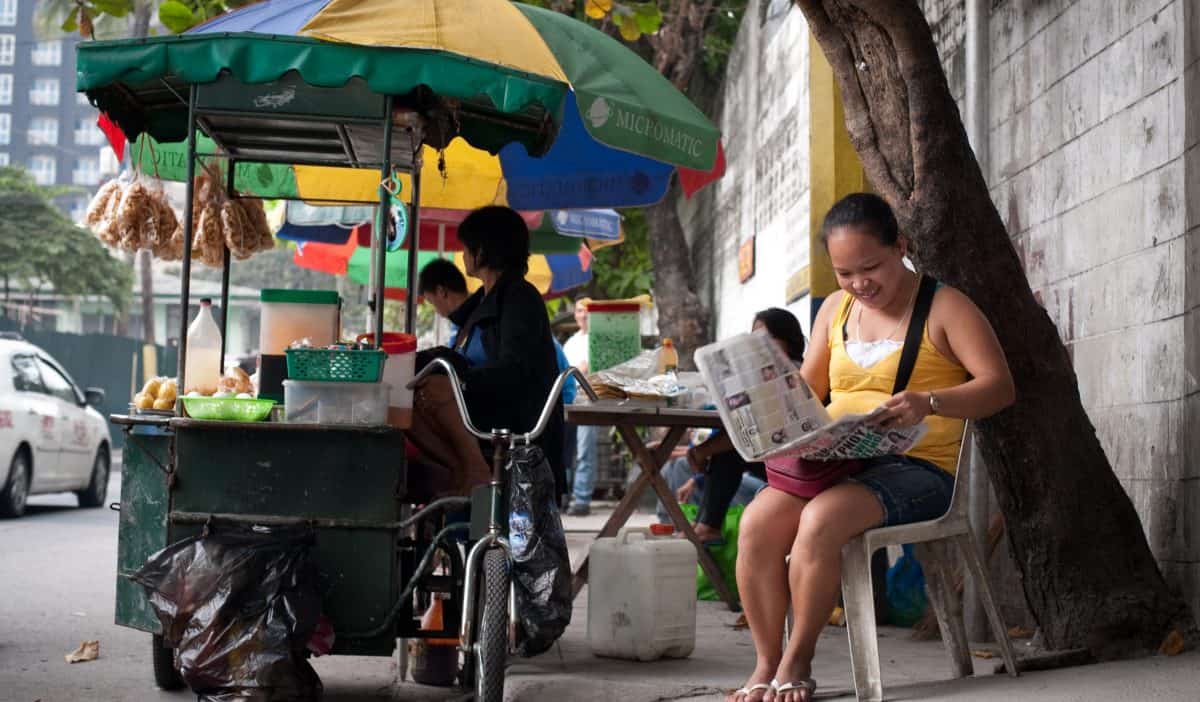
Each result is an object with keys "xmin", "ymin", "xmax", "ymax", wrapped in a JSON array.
[{"xmin": 473, "ymin": 548, "xmax": 509, "ymax": 702}]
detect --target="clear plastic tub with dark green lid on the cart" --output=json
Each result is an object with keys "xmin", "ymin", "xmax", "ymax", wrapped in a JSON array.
[{"xmin": 258, "ymin": 289, "xmax": 340, "ymax": 355}]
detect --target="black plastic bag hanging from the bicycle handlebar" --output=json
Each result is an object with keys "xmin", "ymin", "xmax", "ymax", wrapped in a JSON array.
[{"xmin": 509, "ymin": 446, "xmax": 571, "ymax": 656}]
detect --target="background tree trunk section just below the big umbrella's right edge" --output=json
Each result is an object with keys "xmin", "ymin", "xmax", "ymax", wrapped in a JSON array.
[{"xmin": 646, "ymin": 187, "xmax": 709, "ymax": 371}]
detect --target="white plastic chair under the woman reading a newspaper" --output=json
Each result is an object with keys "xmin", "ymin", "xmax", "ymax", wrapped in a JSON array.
[{"xmin": 841, "ymin": 422, "xmax": 1018, "ymax": 702}]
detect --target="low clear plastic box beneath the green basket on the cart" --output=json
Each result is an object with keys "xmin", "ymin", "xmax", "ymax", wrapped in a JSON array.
[{"xmin": 283, "ymin": 380, "xmax": 390, "ymax": 426}]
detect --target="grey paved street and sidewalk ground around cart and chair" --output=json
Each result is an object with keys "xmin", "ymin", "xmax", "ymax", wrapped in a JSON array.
[{"xmin": 0, "ymin": 463, "xmax": 1200, "ymax": 702}]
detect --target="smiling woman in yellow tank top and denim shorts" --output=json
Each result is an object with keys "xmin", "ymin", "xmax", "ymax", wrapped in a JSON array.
[{"xmin": 728, "ymin": 193, "xmax": 1015, "ymax": 702}]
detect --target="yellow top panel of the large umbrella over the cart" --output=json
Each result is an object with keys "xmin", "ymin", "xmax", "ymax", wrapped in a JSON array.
[{"xmin": 300, "ymin": 0, "xmax": 569, "ymax": 83}]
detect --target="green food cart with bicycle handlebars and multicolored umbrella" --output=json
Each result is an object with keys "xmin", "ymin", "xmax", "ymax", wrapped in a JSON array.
[{"xmin": 84, "ymin": 0, "xmax": 724, "ymax": 700}]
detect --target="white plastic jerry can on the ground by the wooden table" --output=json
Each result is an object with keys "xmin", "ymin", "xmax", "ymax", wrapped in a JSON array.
[{"xmin": 588, "ymin": 527, "xmax": 696, "ymax": 661}]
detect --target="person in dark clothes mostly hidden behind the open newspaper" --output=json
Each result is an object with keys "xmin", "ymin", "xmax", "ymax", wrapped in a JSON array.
[{"xmin": 676, "ymin": 307, "xmax": 804, "ymax": 542}]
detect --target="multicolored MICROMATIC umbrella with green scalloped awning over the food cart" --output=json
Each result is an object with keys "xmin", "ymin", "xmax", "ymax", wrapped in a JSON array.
[{"xmin": 84, "ymin": 0, "xmax": 725, "ymax": 210}]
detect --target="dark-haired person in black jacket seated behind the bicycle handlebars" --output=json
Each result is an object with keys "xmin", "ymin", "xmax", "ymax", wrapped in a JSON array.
[{"xmin": 407, "ymin": 206, "xmax": 565, "ymax": 494}]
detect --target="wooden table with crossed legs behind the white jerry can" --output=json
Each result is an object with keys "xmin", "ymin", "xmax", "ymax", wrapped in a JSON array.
[{"xmin": 566, "ymin": 400, "xmax": 740, "ymax": 611}]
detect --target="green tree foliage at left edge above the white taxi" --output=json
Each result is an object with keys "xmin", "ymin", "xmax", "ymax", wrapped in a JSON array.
[{"xmin": 0, "ymin": 167, "xmax": 133, "ymax": 311}]
